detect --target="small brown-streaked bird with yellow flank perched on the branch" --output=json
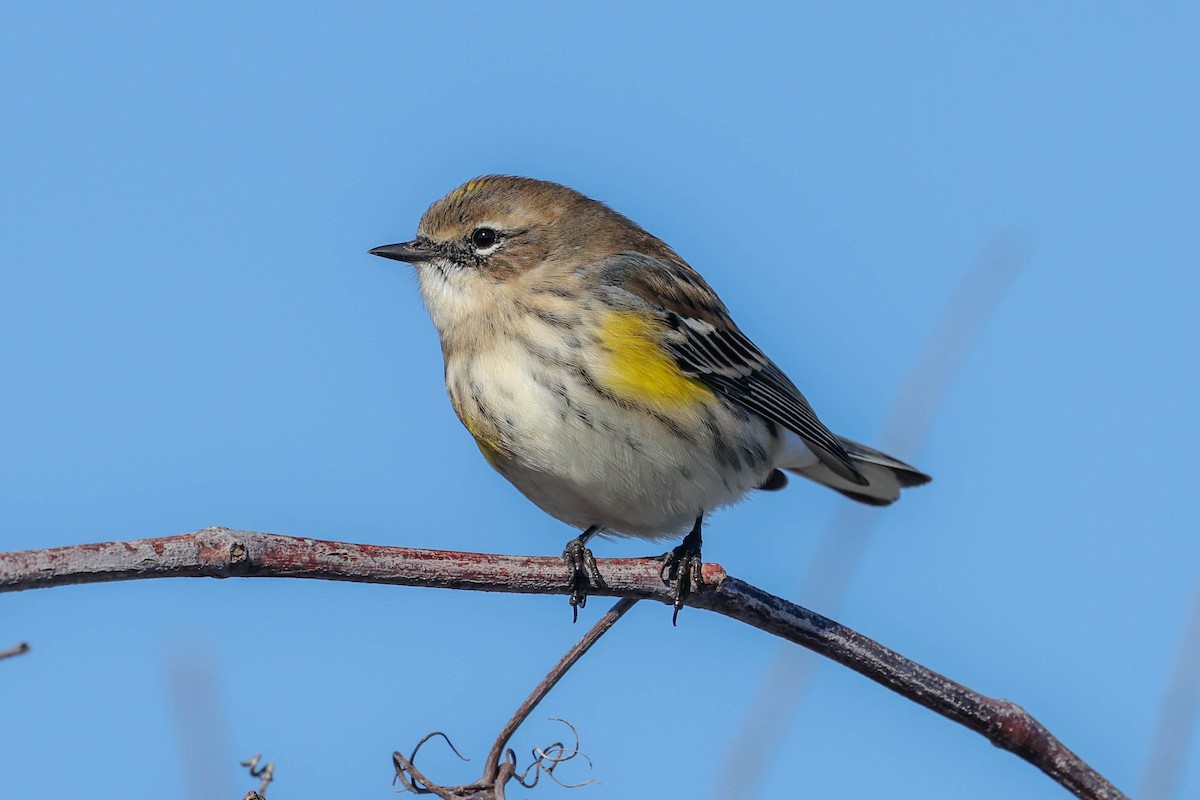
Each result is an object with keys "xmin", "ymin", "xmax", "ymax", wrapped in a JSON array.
[{"xmin": 371, "ymin": 176, "xmax": 930, "ymax": 613}]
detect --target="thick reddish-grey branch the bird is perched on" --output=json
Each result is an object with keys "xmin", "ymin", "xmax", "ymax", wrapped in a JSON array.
[{"xmin": 0, "ymin": 528, "xmax": 1126, "ymax": 800}]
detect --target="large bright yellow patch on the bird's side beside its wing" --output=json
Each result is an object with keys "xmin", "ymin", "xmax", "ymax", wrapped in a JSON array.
[{"xmin": 600, "ymin": 312, "xmax": 713, "ymax": 407}]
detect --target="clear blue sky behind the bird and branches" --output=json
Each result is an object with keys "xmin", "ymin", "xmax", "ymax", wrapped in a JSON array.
[{"xmin": 0, "ymin": 2, "xmax": 1200, "ymax": 800}]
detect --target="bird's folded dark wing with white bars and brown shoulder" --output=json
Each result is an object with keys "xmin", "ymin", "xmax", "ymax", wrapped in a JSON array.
[{"xmin": 595, "ymin": 251, "xmax": 868, "ymax": 486}]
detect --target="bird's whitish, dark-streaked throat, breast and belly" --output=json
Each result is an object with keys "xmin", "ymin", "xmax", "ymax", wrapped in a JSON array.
[{"xmin": 421, "ymin": 262, "xmax": 778, "ymax": 539}]
